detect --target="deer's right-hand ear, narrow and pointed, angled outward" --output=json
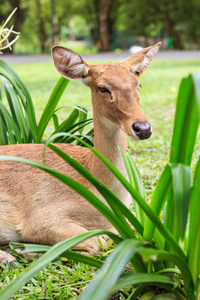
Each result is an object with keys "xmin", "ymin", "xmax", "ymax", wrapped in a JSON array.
[{"xmin": 123, "ymin": 42, "xmax": 162, "ymax": 77}]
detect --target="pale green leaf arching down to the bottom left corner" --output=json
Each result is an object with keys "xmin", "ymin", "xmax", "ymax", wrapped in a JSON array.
[{"xmin": 0, "ymin": 230, "xmax": 110, "ymax": 300}]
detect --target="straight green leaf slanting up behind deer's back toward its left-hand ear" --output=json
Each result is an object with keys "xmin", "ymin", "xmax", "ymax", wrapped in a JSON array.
[{"xmin": 36, "ymin": 77, "xmax": 69, "ymax": 143}]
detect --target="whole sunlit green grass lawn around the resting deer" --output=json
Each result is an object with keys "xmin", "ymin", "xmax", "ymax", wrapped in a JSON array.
[{"xmin": 0, "ymin": 59, "xmax": 200, "ymax": 299}]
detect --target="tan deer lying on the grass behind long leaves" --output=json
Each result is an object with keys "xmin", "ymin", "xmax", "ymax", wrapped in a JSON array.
[{"xmin": 0, "ymin": 42, "xmax": 161, "ymax": 262}]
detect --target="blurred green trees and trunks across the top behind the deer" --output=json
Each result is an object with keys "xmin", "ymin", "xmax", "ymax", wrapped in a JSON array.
[{"xmin": 0, "ymin": 0, "xmax": 200, "ymax": 54}]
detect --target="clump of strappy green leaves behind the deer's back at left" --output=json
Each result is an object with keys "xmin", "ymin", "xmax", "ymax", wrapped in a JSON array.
[{"xmin": 0, "ymin": 60, "xmax": 93, "ymax": 145}]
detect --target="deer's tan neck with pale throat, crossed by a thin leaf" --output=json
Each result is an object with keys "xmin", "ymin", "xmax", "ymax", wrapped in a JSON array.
[{"xmin": 91, "ymin": 114, "xmax": 129, "ymax": 206}]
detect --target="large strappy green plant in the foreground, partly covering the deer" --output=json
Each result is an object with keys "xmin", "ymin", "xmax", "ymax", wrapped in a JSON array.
[{"xmin": 0, "ymin": 74, "xmax": 200, "ymax": 300}]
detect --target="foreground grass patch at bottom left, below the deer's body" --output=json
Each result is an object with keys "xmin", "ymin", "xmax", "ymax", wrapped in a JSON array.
[{"xmin": 0, "ymin": 259, "xmax": 99, "ymax": 300}]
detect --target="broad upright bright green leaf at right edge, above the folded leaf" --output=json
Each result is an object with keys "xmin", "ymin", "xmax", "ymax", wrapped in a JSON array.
[{"xmin": 170, "ymin": 73, "xmax": 200, "ymax": 165}]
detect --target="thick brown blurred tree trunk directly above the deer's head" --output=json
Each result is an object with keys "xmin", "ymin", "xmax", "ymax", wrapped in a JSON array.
[{"xmin": 99, "ymin": 0, "xmax": 113, "ymax": 51}]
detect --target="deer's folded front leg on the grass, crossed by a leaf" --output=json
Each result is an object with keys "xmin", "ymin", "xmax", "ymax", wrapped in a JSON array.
[{"xmin": 22, "ymin": 221, "xmax": 107, "ymax": 256}]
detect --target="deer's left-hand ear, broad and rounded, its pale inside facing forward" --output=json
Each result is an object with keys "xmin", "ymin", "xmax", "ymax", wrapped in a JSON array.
[{"xmin": 52, "ymin": 46, "xmax": 89, "ymax": 80}]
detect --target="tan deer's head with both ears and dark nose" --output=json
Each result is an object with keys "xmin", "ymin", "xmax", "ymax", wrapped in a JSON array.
[{"xmin": 52, "ymin": 43, "xmax": 161, "ymax": 140}]
